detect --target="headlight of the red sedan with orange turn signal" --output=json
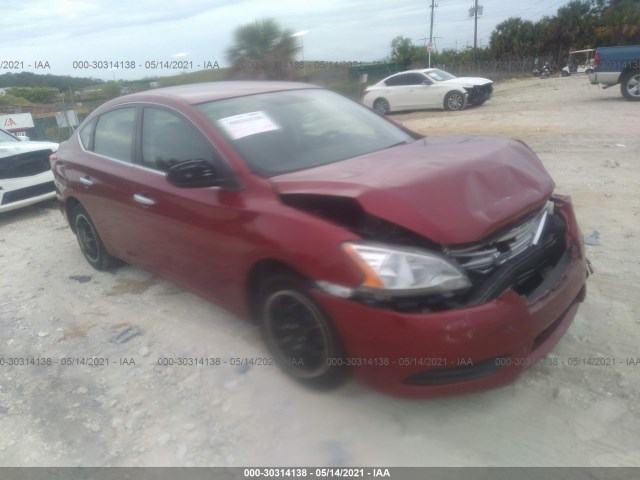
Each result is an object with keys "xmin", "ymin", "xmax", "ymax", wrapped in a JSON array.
[{"xmin": 342, "ymin": 242, "xmax": 471, "ymax": 296}]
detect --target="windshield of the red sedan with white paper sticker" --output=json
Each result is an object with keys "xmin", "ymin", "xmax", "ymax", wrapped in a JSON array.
[{"xmin": 197, "ymin": 89, "xmax": 413, "ymax": 177}]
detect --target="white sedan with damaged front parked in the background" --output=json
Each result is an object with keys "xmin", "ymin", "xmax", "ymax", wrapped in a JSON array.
[{"xmin": 362, "ymin": 68, "xmax": 493, "ymax": 115}]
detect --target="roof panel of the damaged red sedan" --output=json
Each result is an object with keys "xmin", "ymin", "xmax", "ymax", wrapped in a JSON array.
[{"xmin": 110, "ymin": 80, "xmax": 321, "ymax": 105}]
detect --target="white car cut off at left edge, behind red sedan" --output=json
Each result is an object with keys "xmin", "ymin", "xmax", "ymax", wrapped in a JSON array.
[{"xmin": 0, "ymin": 130, "xmax": 58, "ymax": 213}]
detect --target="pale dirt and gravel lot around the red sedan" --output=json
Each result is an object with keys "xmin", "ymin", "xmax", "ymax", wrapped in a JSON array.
[{"xmin": 0, "ymin": 76, "xmax": 640, "ymax": 466}]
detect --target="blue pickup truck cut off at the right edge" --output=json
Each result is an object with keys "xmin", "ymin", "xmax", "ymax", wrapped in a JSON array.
[{"xmin": 589, "ymin": 45, "xmax": 640, "ymax": 101}]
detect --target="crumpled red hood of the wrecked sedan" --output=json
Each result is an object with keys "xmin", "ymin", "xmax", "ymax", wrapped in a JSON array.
[{"xmin": 270, "ymin": 137, "xmax": 555, "ymax": 245}]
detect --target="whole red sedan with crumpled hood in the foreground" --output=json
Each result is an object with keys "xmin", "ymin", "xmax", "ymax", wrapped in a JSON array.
[{"xmin": 52, "ymin": 82, "xmax": 587, "ymax": 396}]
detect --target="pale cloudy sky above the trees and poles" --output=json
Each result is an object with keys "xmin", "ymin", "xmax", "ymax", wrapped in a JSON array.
[{"xmin": 0, "ymin": 0, "xmax": 569, "ymax": 80}]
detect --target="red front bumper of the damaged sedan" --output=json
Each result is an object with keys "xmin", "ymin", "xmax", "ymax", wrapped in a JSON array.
[{"xmin": 316, "ymin": 197, "xmax": 586, "ymax": 397}]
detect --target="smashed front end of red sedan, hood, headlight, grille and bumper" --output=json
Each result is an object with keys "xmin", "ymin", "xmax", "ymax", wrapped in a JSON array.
[{"xmin": 271, "ymin": 137, "xmax": 586, "ymax": 397}]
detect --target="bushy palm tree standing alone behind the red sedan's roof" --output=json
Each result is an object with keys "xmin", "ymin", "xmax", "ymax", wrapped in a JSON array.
[{"xmin": 227, "ymin": 18, "xmax": 299, "ymax": 80}]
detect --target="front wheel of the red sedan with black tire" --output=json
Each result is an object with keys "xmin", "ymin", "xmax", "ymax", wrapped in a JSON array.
[{"xmin": 257, "ymin": 273, "xmax": 347, "ymax": 389}]
